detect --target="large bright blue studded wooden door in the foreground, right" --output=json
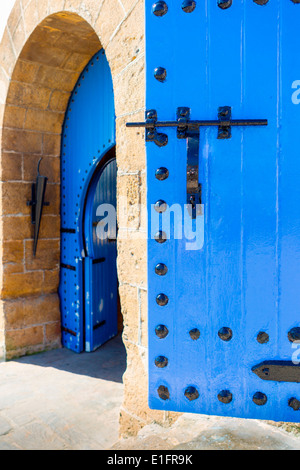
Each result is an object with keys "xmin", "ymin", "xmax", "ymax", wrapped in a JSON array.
[{"xmin": 140, "ymin": 0, "xmax": 300, "ymax": 421}]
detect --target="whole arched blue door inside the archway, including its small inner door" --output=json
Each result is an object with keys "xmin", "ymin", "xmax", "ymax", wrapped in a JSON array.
[{"xmin": 59, "ymin": 49, "xmax": 118, "ymax": 353}]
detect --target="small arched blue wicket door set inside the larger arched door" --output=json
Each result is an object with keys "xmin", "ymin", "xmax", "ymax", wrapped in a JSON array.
[{"xmin": 84, "ymin": 149, "xmax": 118, "ymax": 352}]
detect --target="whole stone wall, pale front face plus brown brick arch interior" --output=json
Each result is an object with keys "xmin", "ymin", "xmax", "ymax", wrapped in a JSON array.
[{"xmin": 0, "ymin": 0, "xmax": 179, "ymax": 435}]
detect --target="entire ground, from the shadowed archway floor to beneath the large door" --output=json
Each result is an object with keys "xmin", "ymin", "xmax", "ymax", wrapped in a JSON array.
[{"xmin": 0, "ymin": 337, "xmax": 300, "ymax": 450}]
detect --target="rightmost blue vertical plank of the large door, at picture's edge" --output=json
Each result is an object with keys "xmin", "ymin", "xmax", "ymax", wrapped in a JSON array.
[{"xmin": 277, "ymin": 3, "xmax": 300, "ymax": 421}]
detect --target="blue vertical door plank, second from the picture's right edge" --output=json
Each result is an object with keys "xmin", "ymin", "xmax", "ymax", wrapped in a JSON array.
[{"xmin": 242, "ymin": 5, "xmax": 278, "ymax": 418}]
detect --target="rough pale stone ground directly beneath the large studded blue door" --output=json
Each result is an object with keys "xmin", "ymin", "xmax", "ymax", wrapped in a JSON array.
[{"xmin": 113, "ymin": 414, "xmax": 300, "ymax": 451}]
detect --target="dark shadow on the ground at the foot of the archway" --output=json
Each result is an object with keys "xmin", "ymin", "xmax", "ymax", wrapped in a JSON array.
[{"xmin": 10, "ymin": 335, "xmax": 126, "ymax": 383}]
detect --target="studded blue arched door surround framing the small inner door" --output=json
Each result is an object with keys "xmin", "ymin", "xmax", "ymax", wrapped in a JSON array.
[{"xmin": 59, "ymin": 50, "xmax": 115, "ymax": 352}]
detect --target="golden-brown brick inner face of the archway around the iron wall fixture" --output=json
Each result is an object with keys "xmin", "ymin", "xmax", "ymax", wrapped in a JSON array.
[{"xmin": 2, "ymin": 12, "xmax": 101, "ymax": 359}]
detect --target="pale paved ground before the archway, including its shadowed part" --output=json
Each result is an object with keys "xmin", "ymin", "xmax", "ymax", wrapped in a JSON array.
[{"xmin": 0, "ymin": 338, "xmax": 126, "ymax": 450}]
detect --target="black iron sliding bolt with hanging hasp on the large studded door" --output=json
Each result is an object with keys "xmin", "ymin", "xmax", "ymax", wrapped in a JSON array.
[{"xmin": 126, "ymin": 106, "xmax": 268, "ymax": 219}]
